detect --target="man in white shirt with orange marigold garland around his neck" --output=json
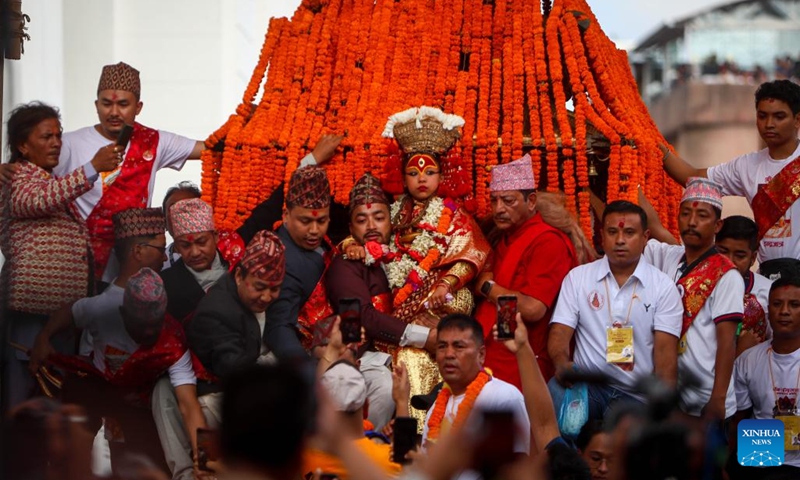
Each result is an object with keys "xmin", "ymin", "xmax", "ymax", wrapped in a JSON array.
[{"xmin": 416, "ymin": 314, "xmax": 531, "ymax": 478}]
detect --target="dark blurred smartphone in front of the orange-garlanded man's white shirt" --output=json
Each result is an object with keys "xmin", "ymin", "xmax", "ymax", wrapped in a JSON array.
[{"xmin": 475, "ymin": 410, "xmax": 516, "ymax": 478}]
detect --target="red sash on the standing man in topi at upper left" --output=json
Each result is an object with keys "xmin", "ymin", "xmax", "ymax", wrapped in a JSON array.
[{"xmin": 86, "ymin": 123, "xmax": 158, "ymax": 279}]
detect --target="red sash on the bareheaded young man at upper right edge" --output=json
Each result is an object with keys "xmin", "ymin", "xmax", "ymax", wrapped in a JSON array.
[{"xmin": 750, "ymin": 157, "xmax": 800, "ymax": 241}]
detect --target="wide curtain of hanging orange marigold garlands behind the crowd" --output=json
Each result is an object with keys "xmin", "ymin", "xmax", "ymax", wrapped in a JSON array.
[{"xmin": 202, "ymin": 0, "xmax": 680, "ymax": 236}]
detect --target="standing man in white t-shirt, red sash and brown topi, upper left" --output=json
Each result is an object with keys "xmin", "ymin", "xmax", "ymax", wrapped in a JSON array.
[{"xmin": 53, "ymin": 62, "xmax": 205, "ymax": 281}]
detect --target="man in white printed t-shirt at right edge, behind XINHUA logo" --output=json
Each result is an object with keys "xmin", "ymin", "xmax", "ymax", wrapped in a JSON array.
[{"xmin": 728, "ymin": 277, "xmax": 800, "ymax": 480}]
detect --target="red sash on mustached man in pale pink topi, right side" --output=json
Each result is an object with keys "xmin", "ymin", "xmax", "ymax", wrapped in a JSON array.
[{"xmin": 678, "ymin": 253, "xmax": 736, "ymax": 338}]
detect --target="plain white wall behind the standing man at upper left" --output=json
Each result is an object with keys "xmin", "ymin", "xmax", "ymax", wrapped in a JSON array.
[{"xmin": 3, "ymin": 0, "xmax": 300, "ymax": 204}]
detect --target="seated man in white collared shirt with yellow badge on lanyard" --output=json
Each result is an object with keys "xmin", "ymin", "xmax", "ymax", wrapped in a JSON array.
[{"xmin": 547, "ymin": 200, "xmax": 683, "ymax": 420}]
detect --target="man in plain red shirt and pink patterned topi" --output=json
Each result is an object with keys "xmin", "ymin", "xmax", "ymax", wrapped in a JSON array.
[{"xmin": 476, "ymin": 155, "xmax": 578, "ymax": 388}]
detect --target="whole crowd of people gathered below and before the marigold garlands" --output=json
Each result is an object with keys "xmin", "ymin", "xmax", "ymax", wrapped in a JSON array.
[{"xmin": 0, "ymin": 63, "xmax": 800, "ymax": 479}]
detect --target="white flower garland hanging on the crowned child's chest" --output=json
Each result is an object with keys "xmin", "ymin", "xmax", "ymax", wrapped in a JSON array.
[{"xmin": 385, "ymin": 195, "xmax": 447, "ymax": 288}]
